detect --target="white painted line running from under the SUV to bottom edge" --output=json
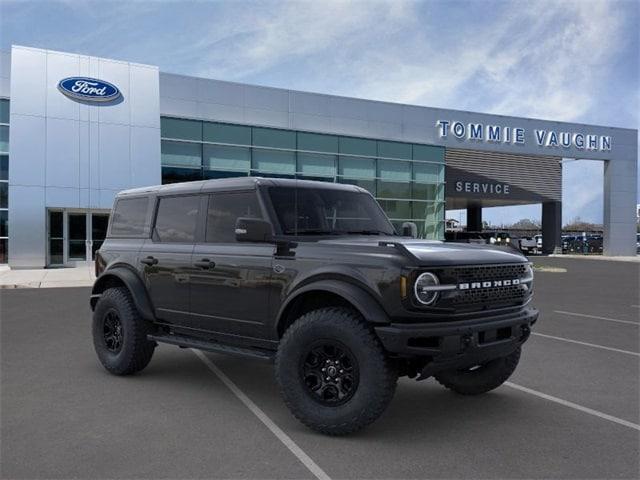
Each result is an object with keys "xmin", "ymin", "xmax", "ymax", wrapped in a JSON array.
[{"xmin": 191, "ymin": 348, "xmax": 331, "ymax": 480}]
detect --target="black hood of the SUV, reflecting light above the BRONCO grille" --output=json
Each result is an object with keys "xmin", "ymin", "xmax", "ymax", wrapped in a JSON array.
[{"xmin": 319, "ymin": 235, "xmax": 527, "ymax": 266}]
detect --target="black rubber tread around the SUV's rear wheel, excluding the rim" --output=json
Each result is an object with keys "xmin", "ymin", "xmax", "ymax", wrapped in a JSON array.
[{"xmin": 94, "ymin": 287, "xmax": 156, "ymax": 375}]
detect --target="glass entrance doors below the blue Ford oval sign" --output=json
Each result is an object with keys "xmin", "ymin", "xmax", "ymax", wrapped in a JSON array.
[{"xmin": 47, "ymin": 209, "xmax": 109, "ymax": 267}]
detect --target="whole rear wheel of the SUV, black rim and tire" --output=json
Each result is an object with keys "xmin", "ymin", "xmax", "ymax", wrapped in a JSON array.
[{"xmin": 92, "ymin": 287, "xmax": 156, "ymax": 375}]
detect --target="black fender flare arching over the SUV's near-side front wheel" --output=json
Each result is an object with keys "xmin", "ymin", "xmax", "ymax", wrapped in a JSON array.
[{"xmin": 276, "ymin": 279, "xmax": 390, "ymax": 331}]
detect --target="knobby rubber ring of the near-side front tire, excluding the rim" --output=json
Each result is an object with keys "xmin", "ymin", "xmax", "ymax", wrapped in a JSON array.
[{"xmin": 275, "ymin": 307, "xmax": 398, "ymax": 436}]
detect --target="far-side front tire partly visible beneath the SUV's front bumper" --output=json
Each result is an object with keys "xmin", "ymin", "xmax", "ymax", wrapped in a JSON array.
[{"xmin": 434, "ymin": 347, "xmax": 520, "ymax": 395}]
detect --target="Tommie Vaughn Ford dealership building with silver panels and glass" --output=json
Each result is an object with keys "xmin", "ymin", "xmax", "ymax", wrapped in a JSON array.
[{"xmin": 0, "ymin": 46, "xmax": 638, "ymax": 268}]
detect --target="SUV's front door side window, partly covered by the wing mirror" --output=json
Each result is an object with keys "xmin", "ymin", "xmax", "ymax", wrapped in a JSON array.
[{"xmin": 206, "ymin": 192, "xmax": 262, "ymax": 243}]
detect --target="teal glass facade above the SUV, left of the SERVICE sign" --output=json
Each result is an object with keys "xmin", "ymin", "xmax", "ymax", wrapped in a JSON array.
[{"xmin": 161, "ymin": 117, "xmax": 445, "ymax": 239}]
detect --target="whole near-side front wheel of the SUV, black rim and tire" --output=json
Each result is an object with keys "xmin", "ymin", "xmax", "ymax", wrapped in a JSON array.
[{"xmin": 275, "ymin": 308, "xmax": 398, "ymax": 435}]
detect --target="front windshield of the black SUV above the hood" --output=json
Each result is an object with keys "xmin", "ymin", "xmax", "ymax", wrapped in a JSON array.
[{"xmin": 269, "ymin": 187, "xmax": 396, "ymax": 235}]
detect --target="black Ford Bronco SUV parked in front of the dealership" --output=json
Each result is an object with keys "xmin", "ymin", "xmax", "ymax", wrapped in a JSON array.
[{"xmin": 91, "ymin": 177, "xmax": 538, "ymax": 435}]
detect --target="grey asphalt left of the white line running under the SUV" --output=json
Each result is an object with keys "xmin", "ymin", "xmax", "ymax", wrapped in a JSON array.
[{"xmin": 0, "ymin": 288, "xmax": 312, "ymax": 479}]
